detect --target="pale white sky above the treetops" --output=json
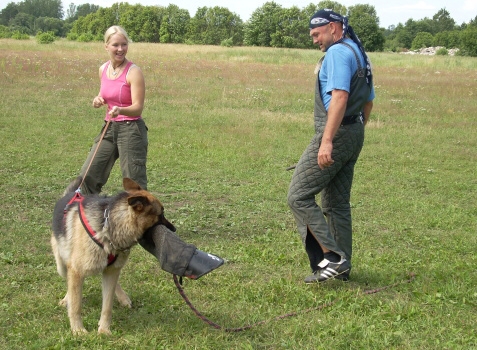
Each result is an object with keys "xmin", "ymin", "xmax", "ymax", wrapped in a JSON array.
[{"xmin": 0, "ymin": 0, "xmax": 477, "ymax": 28}]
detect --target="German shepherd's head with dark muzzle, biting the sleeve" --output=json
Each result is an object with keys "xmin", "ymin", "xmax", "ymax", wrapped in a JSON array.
[{"xmin": 123, "ymin": 178, "xmax": 175, "ymax": 231}]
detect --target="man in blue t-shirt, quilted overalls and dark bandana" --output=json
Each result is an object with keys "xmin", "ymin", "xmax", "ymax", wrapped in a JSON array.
[{"xmin": 288, "ymin": 10, "xmax": 374, "ymax": 283}]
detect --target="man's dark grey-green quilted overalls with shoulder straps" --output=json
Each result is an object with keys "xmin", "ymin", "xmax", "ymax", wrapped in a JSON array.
[{"xmin": 288, "ymin": 43, "xmax": 370, "ymax": 271}]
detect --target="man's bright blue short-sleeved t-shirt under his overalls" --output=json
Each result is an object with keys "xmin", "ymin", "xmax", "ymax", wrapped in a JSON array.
[{"xmin": 319, "ymin": 38, "xmax": 374, "ymax": 110}]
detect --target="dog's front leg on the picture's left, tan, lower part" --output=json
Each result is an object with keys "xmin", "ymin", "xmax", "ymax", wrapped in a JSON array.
[{"xmin": 65, "ymin": 270, "xmax": 88, "ymax": 334}]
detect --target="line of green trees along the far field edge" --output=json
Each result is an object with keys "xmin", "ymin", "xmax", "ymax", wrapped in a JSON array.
[{"xmin": 0, "ymin": 0, "xmax": 477, "ymax": 56}]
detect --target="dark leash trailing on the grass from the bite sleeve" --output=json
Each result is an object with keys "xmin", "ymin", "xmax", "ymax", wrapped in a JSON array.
[{"xmin": 173, "ymin": 272, "xmax": 416, "ymax": 333}]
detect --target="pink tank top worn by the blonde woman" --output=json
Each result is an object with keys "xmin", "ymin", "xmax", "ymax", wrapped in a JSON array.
[{"xmin": 99, "ymin": 61, "xmax": 141, "ymax": 122}]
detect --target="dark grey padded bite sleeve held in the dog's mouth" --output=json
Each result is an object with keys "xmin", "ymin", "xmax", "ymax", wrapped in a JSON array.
[{"xmin": 138, "ymin": 224, "xmax": 224, "ymax": 280}]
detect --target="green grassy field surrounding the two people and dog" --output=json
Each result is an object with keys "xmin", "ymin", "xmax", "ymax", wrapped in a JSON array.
[{"xmin": 0, "ymin": 39, "xmax": 477, "ymax": 350}]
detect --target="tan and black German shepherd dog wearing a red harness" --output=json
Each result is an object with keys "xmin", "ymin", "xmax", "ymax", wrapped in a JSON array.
[{"xmin": 51, "ymin": 177, "xmax": 172, "ymax": 334}]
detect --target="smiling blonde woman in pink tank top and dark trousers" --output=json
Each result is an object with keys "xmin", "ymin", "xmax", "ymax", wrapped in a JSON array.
[{"xmin": 81, "ymin": 26, "xmax": 148, "ymax": 194}]
